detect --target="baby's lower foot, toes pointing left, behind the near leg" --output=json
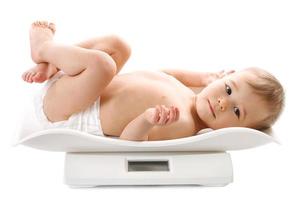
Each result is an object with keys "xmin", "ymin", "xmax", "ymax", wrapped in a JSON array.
[{"xmin": 22, "ymin": 63, "xmax": 58, "ymax": 83}]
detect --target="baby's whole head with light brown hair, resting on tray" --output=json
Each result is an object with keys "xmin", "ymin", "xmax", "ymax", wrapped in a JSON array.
[{"xmin": 196, "ymin": 68, "xmax": 284, "ymax": 130}]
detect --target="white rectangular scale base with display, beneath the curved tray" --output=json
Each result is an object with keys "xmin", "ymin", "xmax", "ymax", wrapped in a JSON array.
[{"xmin": 64, "ymin": 152, "xmax": 233, "ymax": 187}]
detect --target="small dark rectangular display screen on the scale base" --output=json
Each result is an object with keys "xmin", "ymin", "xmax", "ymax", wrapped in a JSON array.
[{"xmin": 127, "ymin": 160, "xmax": 170, "ymax": 172}]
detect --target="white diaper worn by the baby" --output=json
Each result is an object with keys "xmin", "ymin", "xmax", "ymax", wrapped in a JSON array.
[{"xmin": 34, "ymin": 71, "xmax": 104, "ymax": 136}]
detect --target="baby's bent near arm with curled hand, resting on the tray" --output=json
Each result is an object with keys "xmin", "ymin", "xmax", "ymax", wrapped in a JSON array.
[{"xmin": 120, "ymin": 105, "xmax": 179, "ymax": 141}]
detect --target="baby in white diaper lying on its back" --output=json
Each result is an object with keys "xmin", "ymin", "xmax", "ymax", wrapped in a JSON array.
[{"xmin": 22, "ymin": 21, "xmax": 284, "ymax": 141}]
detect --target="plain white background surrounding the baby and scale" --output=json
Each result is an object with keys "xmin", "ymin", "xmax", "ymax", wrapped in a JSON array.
[{"xmin": 0, "ymin": 0, "xmax": 300, "ymax": 199}]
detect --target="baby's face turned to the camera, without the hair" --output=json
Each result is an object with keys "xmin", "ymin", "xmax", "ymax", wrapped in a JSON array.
[{"xmin": 196, "ymin": 71, "xmax": 268, "ymax": 129}]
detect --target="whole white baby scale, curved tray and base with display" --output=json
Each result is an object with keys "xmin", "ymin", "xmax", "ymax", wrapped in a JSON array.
[{"xmin": 14, "ymin": 112, "xmax": 276, "ymax": 187}]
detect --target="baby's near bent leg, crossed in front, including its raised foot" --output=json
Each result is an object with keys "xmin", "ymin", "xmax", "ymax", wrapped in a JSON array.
[{"xmin": 30, "ymin": 23, "xmax": 116, "ymax": 121}]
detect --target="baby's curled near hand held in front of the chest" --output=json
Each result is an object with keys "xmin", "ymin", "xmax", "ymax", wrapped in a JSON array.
[{"xmin": 144, "ymin": 105, "xmax": 179, "ymax": 126}]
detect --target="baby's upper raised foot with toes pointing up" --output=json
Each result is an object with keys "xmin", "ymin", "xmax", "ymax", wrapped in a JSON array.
[{"xmin": 30, "ymin": 21, "xmax": 55, "ymax": 64}]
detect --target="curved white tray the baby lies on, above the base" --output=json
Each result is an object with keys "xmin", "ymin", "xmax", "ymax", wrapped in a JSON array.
[{"xmin": 17, "ymin": 127, "xmax": 276, "ymax": 152}]
